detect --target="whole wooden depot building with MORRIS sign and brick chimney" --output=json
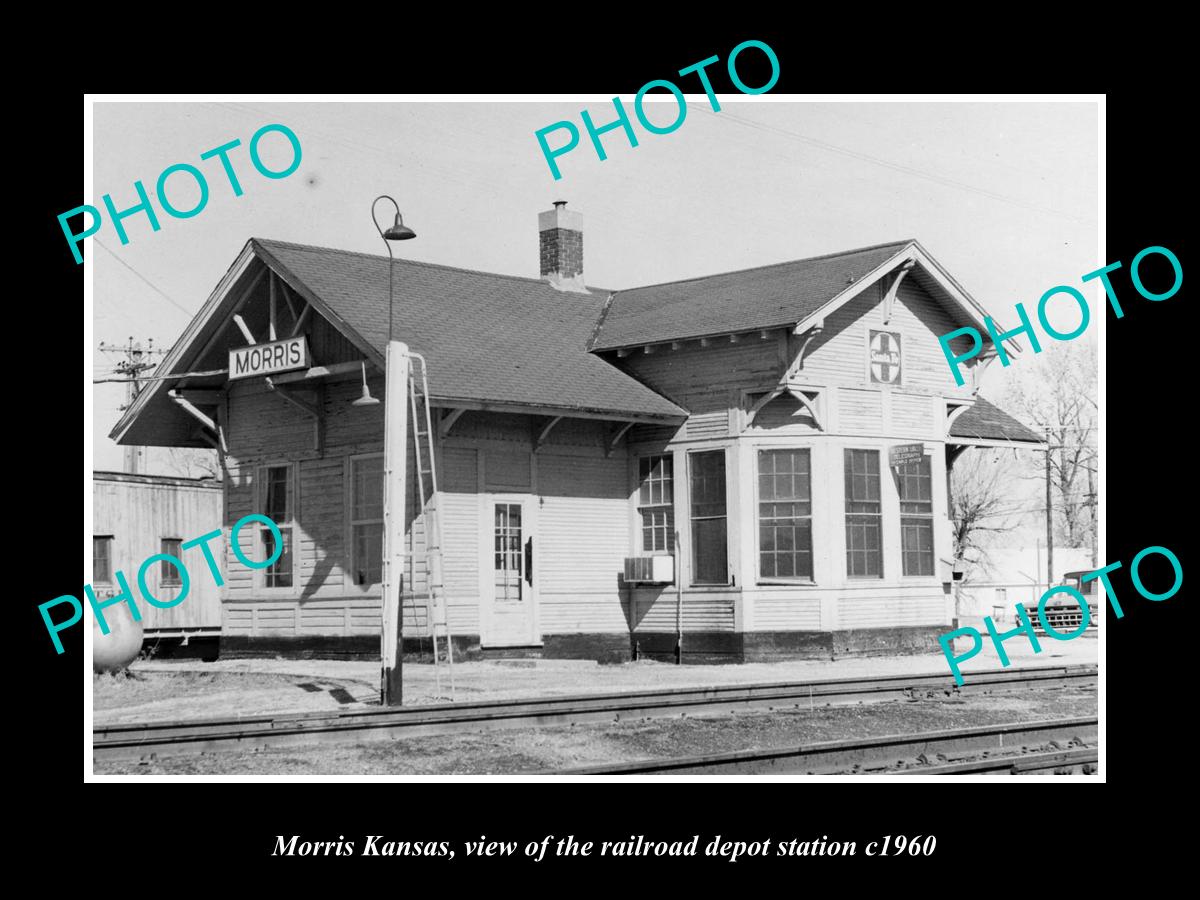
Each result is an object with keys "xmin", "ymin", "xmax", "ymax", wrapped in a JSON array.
[{"xmin": 113, "ymin": 203, "xmax": 1040, "ymax": 661}]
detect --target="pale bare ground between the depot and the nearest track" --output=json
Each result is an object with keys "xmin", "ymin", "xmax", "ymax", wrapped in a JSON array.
[{"xmin": 92, "ymin": 637, "xmax": 1097, "ymax": 726}]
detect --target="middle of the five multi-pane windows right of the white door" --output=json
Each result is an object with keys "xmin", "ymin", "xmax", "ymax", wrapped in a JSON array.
[{"xmin": 758, "ymin": 450, "xmax": 812, "ymax": 578}]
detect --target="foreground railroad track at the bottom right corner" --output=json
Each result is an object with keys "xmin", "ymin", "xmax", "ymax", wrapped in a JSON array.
[{"xmin": 552, "ymin": 718, "xmax": 1098, "ymax": 775}]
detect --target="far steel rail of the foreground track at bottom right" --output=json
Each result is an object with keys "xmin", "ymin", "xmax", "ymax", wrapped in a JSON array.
[{"xmin": 549, "ymin": 716, "xmax": 1098, "ymax": 775}]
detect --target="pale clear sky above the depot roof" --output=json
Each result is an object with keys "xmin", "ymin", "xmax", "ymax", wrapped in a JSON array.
[{"xmin": 88, "ymin": 94, "xmax": 1110, "ymax": 473}]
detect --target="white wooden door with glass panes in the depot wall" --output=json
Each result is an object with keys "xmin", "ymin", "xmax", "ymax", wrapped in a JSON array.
[{"xmin": 479, "ymin": 494, "xmax": 538, "ymax": 648}]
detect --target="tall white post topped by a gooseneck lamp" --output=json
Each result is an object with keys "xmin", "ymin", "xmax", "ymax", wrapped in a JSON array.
[{"xmin": 369, "ymin": 194, "xmax": 416, "ymax": 707}]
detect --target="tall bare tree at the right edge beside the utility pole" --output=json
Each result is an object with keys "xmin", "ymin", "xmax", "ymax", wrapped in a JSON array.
[{"xmin": 1006, "ymin": 341, "xmax": 1098, "ymax": 562}]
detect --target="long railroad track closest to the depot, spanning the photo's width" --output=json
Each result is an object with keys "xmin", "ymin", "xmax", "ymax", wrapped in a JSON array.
[{"xmin": 92, "ymin": 666, "xmax": 1097, "ymax": 761}]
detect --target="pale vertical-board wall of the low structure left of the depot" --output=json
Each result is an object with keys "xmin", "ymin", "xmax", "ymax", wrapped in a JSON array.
[{"xmin": 92, "ymin": 473, "xmax": 228, "ymax": 632}]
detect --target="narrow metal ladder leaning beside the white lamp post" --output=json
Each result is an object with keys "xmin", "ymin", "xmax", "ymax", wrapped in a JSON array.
[{"xmin": 408, "ymin": 353, "xmax": 456, "ymax": 702}]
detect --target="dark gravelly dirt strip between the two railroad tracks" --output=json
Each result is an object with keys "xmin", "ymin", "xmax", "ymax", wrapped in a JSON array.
[{"xmin": 96, "ymin": 689, "xmax": 1097, "ymax": 775}]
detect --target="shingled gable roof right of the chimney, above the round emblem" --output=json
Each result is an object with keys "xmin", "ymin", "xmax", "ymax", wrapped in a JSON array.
[{"xmin": 589, "ymin": 240, "xmax": 1020, "ymax": 353}]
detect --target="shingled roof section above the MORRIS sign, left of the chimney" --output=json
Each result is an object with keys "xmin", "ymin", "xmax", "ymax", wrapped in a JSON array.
[{"xmin": 112, "ymin": 238, "xmax": 686, "ymax": 445}]
